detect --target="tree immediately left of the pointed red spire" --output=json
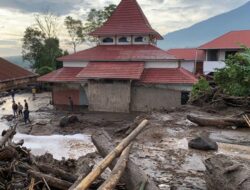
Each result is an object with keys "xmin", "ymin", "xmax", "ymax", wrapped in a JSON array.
[{"xmin": 83, "ymin": 4, "xmax": 116, "ymax": 42}]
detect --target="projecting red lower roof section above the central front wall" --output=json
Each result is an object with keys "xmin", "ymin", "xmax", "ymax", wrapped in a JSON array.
[{"xmin": 77, "ymin": 62, "xmax": 144, "ymax": 79}]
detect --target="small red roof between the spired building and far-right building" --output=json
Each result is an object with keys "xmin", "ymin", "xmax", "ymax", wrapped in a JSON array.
[{"xmin": 167, "ymin": 48, "xmax": 205, "ymax": 61}]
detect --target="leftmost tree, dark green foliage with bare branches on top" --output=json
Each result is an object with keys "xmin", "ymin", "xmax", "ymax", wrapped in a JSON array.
[{"xmin": 22, "ymin": 13, "xmax": 65, "ymax": 74}]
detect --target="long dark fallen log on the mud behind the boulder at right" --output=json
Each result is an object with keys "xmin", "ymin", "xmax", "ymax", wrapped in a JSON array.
[{"xmin": 187, "ymin": 115, "xmax": 247, "ymax": 127}]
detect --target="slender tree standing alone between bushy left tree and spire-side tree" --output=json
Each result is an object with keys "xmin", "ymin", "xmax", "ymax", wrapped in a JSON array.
[{"xmin": 64, "ymin": 16, "xmax": 85, "ymax": 52}]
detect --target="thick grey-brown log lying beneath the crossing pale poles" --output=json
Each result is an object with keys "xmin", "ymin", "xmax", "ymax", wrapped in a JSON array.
[{"xmin": 92, "ymin": 130, "xmax": 159, "ymax": 190}]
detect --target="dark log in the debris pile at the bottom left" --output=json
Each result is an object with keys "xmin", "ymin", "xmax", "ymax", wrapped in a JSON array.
[{"xmin": 37, "ymin": 164, "xmax": 78, "ymax": 183}]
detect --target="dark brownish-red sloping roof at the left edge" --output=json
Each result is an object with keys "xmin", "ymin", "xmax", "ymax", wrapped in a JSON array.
[{"xmin": 0, "ymin": 57, "xmax": 36, "ymax": 82}]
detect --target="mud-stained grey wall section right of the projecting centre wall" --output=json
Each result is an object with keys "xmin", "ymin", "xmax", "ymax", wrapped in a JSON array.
[{"xmin": 131, "ymin": 85, "xmax": 181, "ymax": 111}]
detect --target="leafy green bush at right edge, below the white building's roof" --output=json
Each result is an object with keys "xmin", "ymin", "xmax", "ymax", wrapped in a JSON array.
[{"xmin": 214, "ymin": 49, "xmax": 250, "ymax": 96}]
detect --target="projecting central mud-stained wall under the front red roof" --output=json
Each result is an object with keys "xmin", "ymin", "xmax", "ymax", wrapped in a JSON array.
[{"xmin": 88, "ymin": 80, "xmax": 131, "ymax": 112}]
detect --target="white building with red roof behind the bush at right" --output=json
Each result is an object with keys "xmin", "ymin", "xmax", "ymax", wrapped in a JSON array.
[{"xmin": 198, "ymin": 30, "xmax": 250, "ymax": 74}]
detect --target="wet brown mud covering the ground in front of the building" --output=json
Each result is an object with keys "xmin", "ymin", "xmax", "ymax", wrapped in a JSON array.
[{"xmin": 0, "ymin": 93, "xmax": 250, "ymax": 190}]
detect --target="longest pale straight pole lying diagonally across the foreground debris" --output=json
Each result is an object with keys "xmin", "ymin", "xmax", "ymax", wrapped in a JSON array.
[{"xmin": 75, "ymin": 119, "xmax": 148, "ymax": 190}]
